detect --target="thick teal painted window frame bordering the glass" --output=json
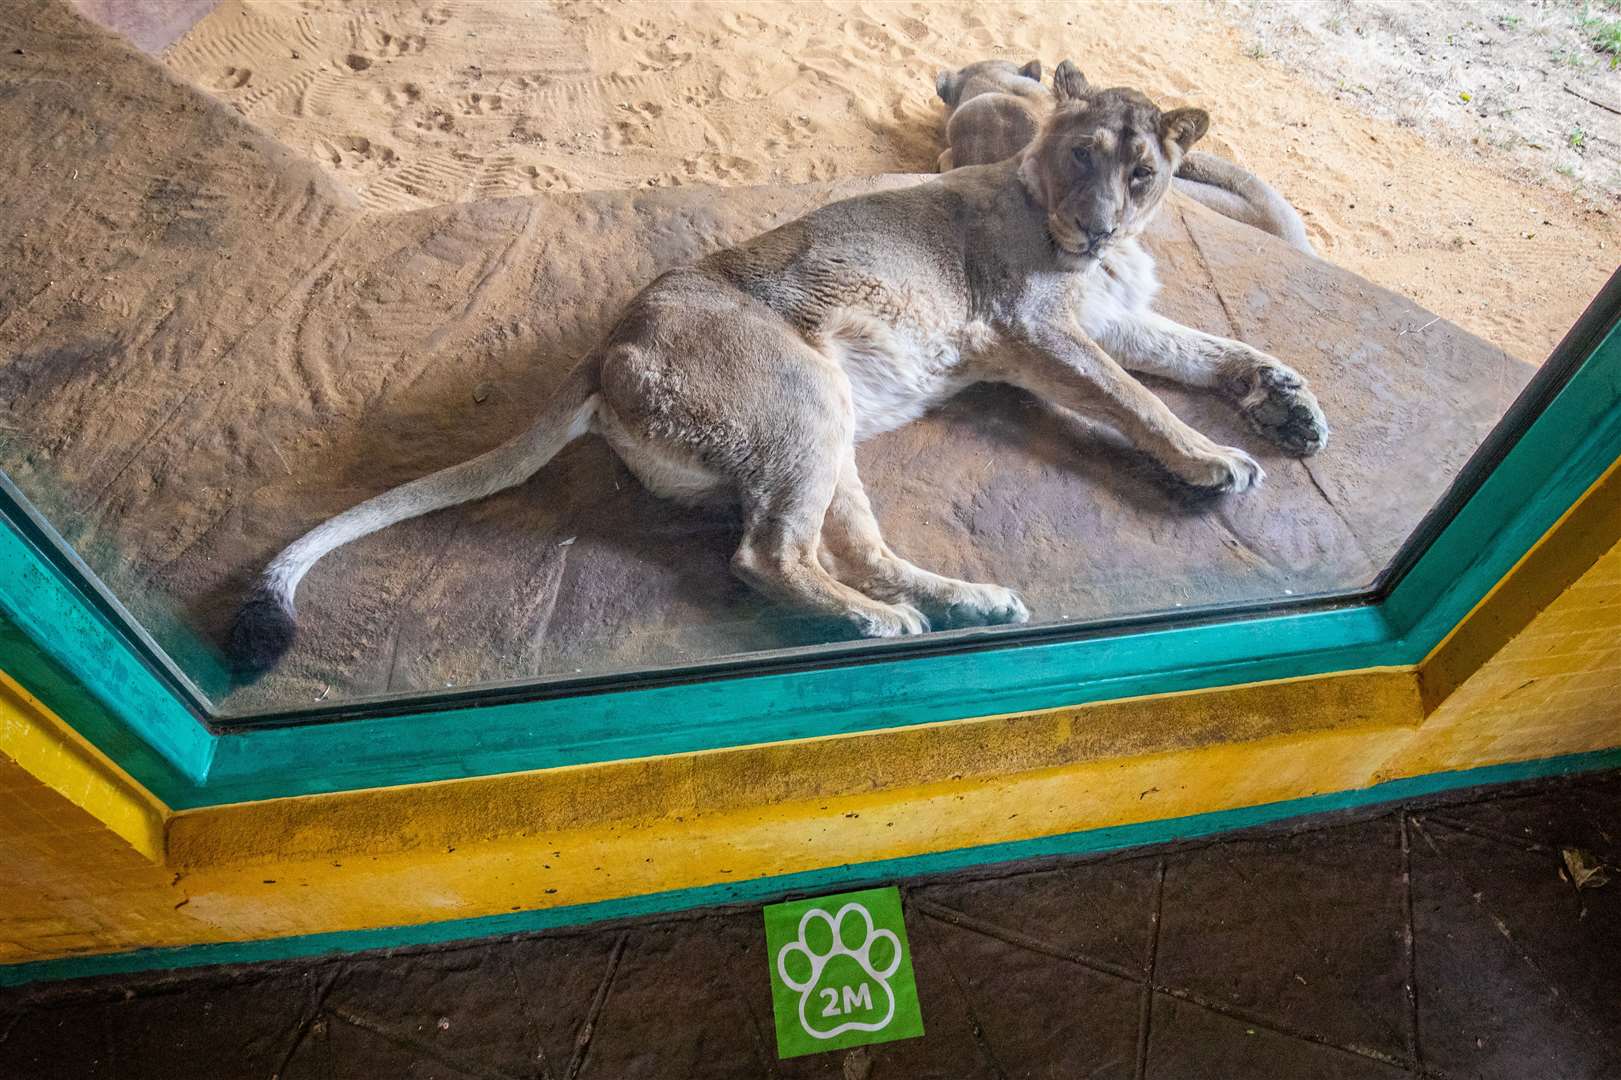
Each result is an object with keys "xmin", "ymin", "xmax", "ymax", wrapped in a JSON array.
[{"xmin": 0, "ymin": 274, "xmax": 1621, "ymax": 809}]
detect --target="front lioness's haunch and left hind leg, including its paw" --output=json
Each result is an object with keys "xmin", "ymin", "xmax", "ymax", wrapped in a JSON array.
[{"xmin": 601, "ymin": 276, "xmax": 929, "ymax": 637}]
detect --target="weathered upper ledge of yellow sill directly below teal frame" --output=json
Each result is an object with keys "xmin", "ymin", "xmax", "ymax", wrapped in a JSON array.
[{"xmin": 169, "ymin": 670, "xmax": 1420, "ymax": 866}]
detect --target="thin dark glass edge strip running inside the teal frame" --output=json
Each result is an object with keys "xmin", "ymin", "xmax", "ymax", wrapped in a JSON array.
[{"xmin": 0, "ymin": 271, "xmax": 1621, "ymax": 733}]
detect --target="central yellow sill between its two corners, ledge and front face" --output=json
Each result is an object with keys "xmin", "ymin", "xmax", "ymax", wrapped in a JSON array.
[{"xmin": 117, "ymin": 671, "xmax": 1621, "ymax": 944}]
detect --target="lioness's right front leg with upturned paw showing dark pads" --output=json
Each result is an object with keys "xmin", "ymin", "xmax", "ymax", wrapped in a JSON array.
[{"xmin": 1101, "ymin": 311, "xmax": 1328, "ymax": 456}]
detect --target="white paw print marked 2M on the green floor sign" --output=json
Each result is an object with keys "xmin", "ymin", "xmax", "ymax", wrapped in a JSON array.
[{"xmin": 776, "ymin": 903, "xmax": 901, "ymax": 1039}]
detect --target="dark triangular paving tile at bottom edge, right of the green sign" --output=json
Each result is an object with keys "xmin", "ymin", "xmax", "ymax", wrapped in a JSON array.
[{"xmin": 1143, "ymin": 994, "xmax": 1407, "ymax": 1080}]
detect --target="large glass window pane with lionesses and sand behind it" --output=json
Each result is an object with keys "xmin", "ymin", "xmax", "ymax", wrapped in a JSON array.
[{"xmin": 0, "ymin": 0, "xmax": 1621, "ymax": 717}]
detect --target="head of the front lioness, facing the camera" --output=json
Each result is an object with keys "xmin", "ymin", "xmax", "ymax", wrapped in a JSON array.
[{"xmin": 1020, "ymin": 60, "xmax": 1209, "ymax": 264}]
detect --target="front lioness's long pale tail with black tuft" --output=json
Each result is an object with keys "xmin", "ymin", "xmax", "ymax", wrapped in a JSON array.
[{"xmin": 229, "ymin": 360, "xmax": 597, "ymax": 676}]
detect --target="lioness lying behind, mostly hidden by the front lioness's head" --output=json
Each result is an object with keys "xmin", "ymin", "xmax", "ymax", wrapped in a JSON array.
[{"xmin": 934, "ymin": 60, "xmax": 1316, "ymax": 255}]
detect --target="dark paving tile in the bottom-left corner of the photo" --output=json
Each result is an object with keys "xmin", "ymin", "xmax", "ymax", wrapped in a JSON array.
[{"xmin": 0, "ymin": 976, "xmax": 310, "ymax": 1080}]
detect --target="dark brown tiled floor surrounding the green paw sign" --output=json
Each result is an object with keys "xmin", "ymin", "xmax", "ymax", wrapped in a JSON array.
[{"xmin": 0, "ymin": 774, "xmax": 1621, "ymax": 1080}]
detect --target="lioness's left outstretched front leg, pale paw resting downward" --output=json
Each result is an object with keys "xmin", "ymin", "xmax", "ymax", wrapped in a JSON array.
[{"xmin": 995, "ymin": 326, "xmax": 1266, "ymax": 491}]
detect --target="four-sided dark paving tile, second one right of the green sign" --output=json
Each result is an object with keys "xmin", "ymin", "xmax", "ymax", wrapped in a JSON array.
[{"xmin": 1154, "ymin": 817, "xmax": 1409, "ymax": 1057}]
